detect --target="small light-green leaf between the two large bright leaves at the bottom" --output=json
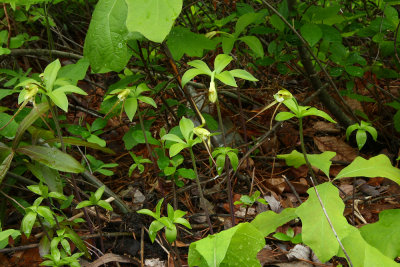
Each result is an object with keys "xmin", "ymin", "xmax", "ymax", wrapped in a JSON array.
[{"xmin": 251, "ymin": 208, "xmax": 298, "ymax": 236}]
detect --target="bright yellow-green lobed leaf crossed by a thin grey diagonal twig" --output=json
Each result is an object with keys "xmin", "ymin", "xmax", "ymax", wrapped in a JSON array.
[{"xmin": 296, "ymin": 183, "xmax": 349, "ymax": 262}]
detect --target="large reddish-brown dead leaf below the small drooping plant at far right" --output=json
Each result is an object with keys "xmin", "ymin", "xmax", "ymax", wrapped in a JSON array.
[{"xmin": 314, "ymin": 136, "xmax": 357, "ymax": 162}]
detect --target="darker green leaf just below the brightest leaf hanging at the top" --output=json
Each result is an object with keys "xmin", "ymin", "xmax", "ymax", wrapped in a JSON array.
[{"xmin": 167, "ymin": 26, "xmax": 217, "ymax": 60}]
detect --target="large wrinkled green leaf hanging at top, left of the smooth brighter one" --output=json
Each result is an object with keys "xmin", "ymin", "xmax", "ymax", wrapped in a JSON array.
[{"xmin": 83, "ymin": 0, "xmax": 130, "ymax": 73}]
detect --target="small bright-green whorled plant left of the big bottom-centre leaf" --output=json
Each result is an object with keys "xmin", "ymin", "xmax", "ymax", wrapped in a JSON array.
[{"xmin": 137, "ymin": 198, "xmax": 192, "ymax": 244}]
